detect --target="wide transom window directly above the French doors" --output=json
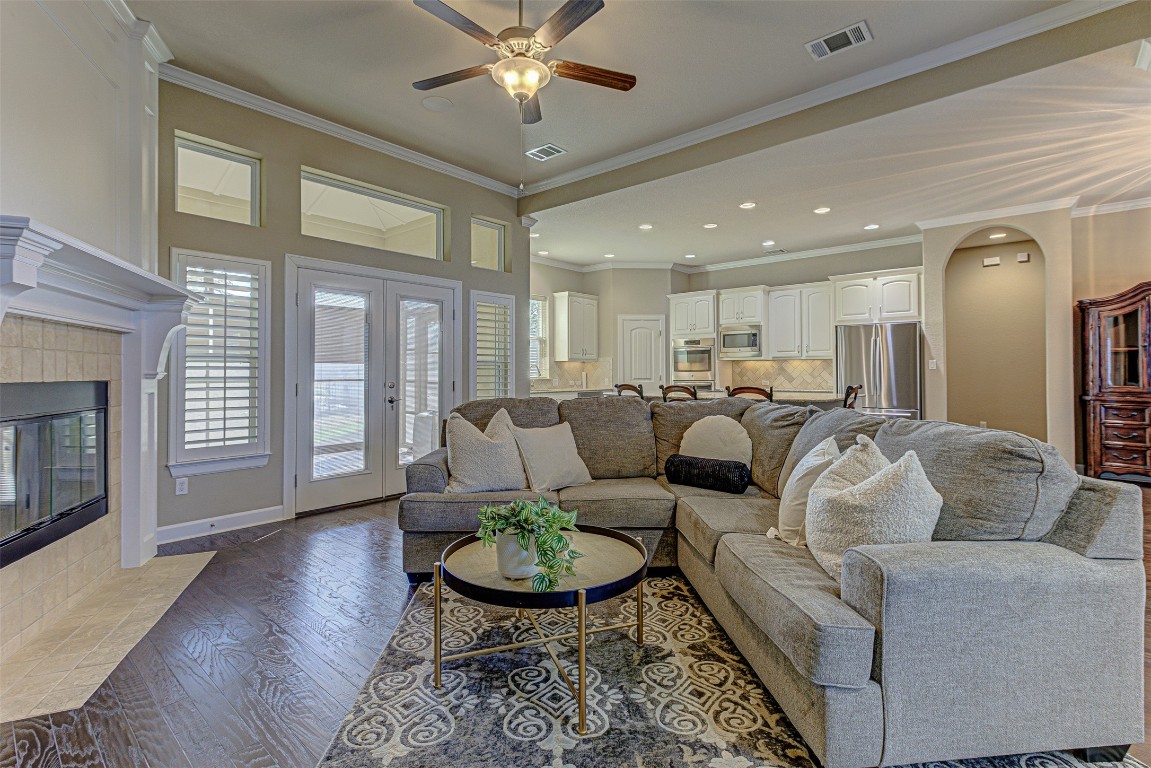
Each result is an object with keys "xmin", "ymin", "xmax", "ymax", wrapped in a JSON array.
[{"xmin": 299, "ymin": 168, "xmax": 444, "ymax": 259}]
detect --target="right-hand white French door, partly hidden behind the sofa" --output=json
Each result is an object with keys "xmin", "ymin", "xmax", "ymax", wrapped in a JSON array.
[{"xmin": 381, "ymin": 280, "xmax": 455, "ymax": 496}]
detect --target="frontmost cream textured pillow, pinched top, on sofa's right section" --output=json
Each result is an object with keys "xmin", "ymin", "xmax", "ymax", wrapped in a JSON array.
[{"xmin": 807, "ymin": 435, "xmax": 943, "ymax": 581}]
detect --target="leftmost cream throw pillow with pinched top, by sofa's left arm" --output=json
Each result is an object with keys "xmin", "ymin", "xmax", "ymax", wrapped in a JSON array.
[{"xmin": 444, "ymin": 408, "xmax": 527, "ymax": 493}]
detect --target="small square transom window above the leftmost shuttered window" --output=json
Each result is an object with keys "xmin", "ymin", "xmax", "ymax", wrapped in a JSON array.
[{"xmin": 176, "ymin": 135, "xmax": 260, "ymax": 227}]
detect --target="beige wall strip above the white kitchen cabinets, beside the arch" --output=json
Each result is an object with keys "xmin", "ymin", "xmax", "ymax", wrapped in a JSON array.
[{"xmin": 688, "ymin": 243, "xmax": 923, "ymax": 290}]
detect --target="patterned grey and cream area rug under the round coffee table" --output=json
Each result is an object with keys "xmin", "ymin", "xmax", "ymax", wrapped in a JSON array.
[{"xmin": 320, "ymin": 577, "xmax": 1141, "ymax": 768}]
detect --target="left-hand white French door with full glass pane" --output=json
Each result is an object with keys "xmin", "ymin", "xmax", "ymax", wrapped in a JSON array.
[{"xmin": 296, "ymin": 269, "xmax": 384, "ymax": 512}]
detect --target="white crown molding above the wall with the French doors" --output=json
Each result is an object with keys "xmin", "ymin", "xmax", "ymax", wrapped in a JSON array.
[{"xmin": 160, "ymin": 64, "xmax": 520, "ymax": 198}]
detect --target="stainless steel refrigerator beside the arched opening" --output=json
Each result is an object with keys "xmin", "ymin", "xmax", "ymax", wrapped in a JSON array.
[{"xmin": 836, "ymin": 322, "xmax": 922, "ymax": 419}]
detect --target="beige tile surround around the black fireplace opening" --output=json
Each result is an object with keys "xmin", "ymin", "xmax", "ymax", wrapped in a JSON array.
[{"xmin": 0, "ymin": 313, "xmax": 121, "ymax": 664}]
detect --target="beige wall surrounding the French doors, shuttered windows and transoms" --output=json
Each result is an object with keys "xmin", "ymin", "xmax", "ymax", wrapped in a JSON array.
[{"xmin": 159, "ymin": 83, "xmax": 528, "ymax": 526}]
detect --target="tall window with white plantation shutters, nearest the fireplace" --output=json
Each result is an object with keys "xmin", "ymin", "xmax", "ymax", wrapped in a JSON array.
[{"xmin": 168, "ymin": 250, "xmax": 272, "ymax": 477}]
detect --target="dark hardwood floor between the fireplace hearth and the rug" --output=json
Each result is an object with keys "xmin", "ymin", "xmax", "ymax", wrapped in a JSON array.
[{"xmin": 0, "ymin": 491, "xmax": 1151, "ymax": 768}]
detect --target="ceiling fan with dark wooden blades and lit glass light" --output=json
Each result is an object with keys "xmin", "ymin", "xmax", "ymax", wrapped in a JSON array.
[{"xmin": 412, "ymin": 0, "xmax": 635, "ymax": 124}]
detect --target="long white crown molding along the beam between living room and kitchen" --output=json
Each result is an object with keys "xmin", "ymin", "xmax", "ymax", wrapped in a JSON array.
[{"xmin": 524, "ymin": 0, "xmax": 1137, "ymax": 197}]
